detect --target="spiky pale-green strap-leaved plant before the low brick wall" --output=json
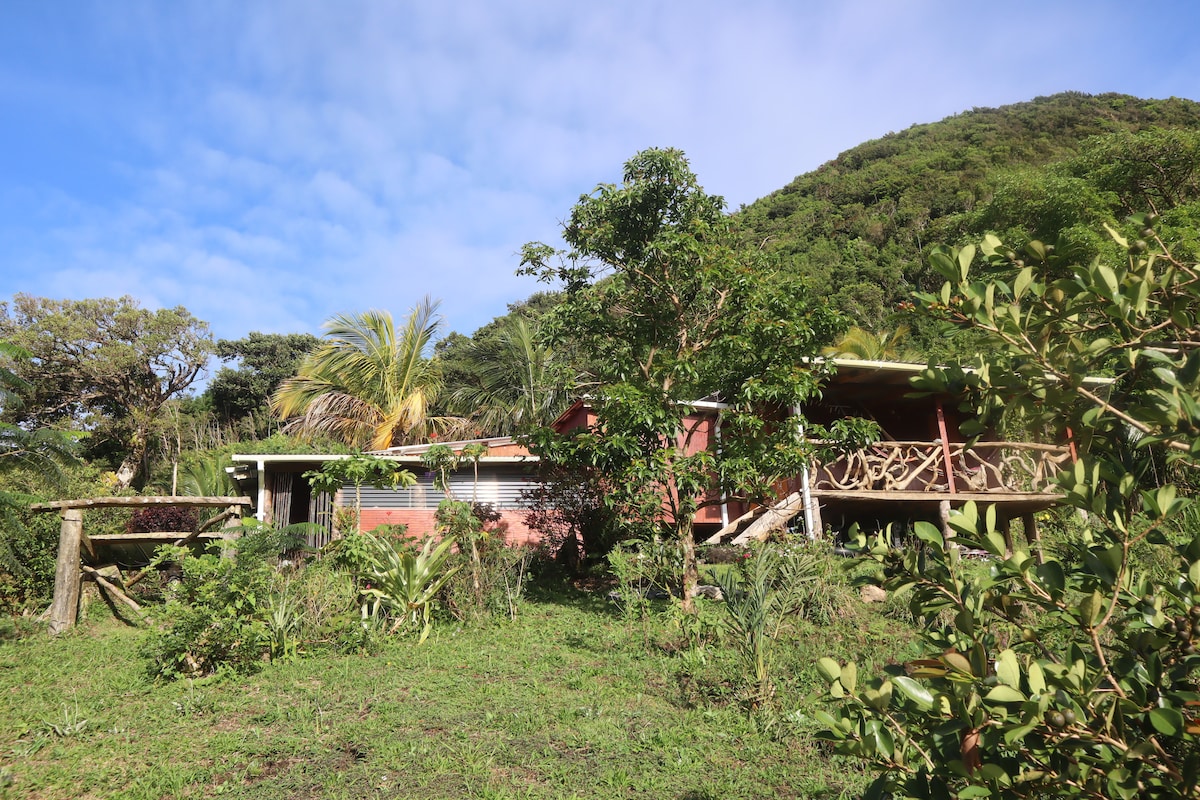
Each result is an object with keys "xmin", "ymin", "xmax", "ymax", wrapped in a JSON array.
[{"xmin": 361, "ymin": 534, "xmax": 461, "ymax": 642}]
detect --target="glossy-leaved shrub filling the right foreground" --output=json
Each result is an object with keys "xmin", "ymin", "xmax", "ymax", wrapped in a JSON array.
[{"xmin": 820, "ymin": 216, "xmax": 1200, "ymax": 798}]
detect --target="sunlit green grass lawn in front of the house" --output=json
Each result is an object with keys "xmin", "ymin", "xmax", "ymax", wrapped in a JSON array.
[{"xmin": 0, "ymin": 593, "xmax": 906, "ymax": 800}]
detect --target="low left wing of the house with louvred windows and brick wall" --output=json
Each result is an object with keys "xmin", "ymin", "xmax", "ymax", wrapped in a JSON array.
[{"xmin": 233, "ymin": 437, "xmax": 538, "ymax": 547}]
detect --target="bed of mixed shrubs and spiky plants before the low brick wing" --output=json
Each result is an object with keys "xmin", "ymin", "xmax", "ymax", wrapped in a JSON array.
[{"xmin": 145, "ymin": 525, "xmax": 529, "ymax": 678}]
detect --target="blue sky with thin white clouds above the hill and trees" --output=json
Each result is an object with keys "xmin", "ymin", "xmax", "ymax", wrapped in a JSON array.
[{"xmin": 0, "ymin": 0, "xmax": 1200, "ymax": 355}]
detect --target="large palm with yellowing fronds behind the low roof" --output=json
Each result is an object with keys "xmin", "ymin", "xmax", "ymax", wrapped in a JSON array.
[{"xmin": 271, "ymin": 297, "xmax": 458, "ymax": 450}]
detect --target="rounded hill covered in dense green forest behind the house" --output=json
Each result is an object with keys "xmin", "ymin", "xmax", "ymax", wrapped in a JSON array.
[{"xmin": 737, "ymin": 92, "xmax": 1200, "ymax": 340}]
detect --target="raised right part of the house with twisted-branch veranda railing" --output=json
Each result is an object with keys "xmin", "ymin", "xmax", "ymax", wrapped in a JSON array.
[{"xmin": 556, "ymin": 359, "xmax": 1106, "ymax": 551}]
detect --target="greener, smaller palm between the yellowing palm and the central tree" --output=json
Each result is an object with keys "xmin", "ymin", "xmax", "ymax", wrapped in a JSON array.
[{"xmin": 450, "ymin": 317, "xmax": 565, "ymax": 434}]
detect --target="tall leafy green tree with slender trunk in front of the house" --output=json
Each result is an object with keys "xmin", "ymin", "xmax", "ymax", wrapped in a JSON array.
[{"xmin": 522, "ymin": 150, "xmax": 841, "ymax": 609}]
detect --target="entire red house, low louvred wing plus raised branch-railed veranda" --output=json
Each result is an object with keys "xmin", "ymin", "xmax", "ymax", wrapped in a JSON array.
[{"xmin": 233, "ymin": 359, "xmax": 1109, "ymax": 554}]
